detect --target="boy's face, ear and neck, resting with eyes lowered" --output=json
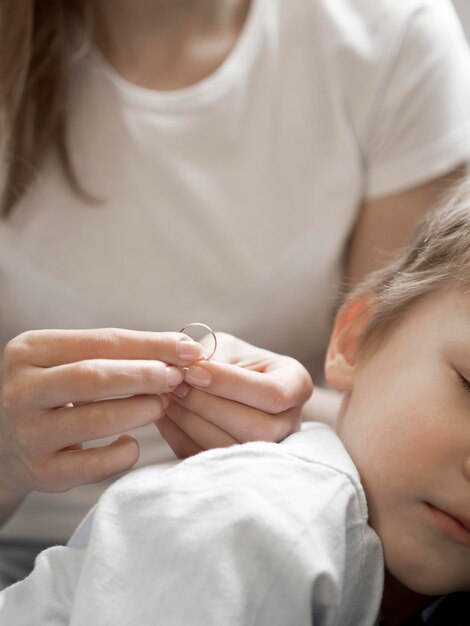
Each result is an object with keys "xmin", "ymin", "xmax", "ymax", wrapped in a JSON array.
[{"xmin": 325, "ymin": 288, "xmax": 470, "ymax": 625}]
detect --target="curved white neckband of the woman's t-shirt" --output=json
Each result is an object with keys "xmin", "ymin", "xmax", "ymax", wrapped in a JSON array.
[{"xmin": 91, "ymin": 0, "xmax": 266, "ymax": 111}]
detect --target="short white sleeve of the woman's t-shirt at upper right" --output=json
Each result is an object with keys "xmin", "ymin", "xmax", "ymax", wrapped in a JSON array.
[{"xmin": 361, "ymin": 0, "xmax": 470, "ymax": 197}]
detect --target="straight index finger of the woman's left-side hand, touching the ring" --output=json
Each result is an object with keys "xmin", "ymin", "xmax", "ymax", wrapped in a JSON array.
[{"xmin": 5, "ymin": 328, "xmax": 203, "ymax": 367}]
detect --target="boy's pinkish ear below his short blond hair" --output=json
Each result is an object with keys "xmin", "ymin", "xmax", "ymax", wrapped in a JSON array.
[{"xmin": 325, "ymin": 296, "xmax": 374, "ymax": 391}]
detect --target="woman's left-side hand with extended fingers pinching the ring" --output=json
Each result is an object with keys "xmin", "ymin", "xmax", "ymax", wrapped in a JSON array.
[{"xmin": 0, "ymin": 329, "xmax": 202, "ymax": 509}]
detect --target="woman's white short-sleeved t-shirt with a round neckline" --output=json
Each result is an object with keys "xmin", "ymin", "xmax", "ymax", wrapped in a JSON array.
[{"xmin": 0, "ymin": 0, "xmax": 470, "ymax": 540}]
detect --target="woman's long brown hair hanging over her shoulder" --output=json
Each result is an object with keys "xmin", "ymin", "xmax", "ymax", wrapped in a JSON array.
[{"xmin": 0, "ymin": 0, "xmax": 86, "ymax": 217}]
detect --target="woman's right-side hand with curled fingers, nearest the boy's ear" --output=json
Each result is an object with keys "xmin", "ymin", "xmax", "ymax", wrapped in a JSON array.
[{"xmin": 157, "ymin": 333, "xmax": 313, "ymax": 458}]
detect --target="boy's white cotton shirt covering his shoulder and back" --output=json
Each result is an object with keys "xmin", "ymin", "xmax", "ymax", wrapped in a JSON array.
[{"xmin": 0, "ymin": 424, "xmax": 383, "ymax": 626}]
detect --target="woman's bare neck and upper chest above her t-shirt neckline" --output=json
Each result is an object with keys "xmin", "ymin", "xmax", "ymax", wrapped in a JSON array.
[{"xmin": 90, "ymin": 0, "xmax": 252, "ymax": 90}]
